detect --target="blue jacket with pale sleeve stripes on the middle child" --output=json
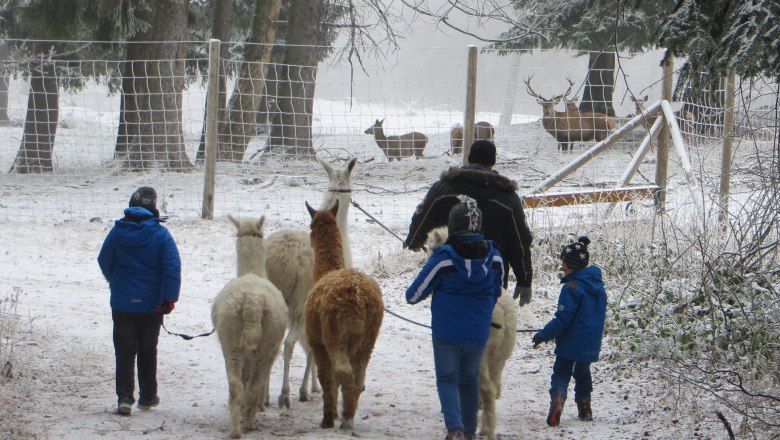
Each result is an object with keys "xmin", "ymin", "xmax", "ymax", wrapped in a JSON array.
[{"xmin": 406, "ymin": 234, "xmax": 505, "ymax": 342}]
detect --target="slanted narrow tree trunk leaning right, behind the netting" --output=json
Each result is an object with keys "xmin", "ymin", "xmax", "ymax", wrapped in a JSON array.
[{"xmin": 217, "ymin": 0, "xmax": 282, "ymax": 162}]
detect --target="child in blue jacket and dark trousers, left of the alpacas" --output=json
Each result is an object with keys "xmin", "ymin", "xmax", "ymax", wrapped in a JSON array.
[{"xmin": 98, "ymin": 187, "xmax": 181, "ymax": 416}]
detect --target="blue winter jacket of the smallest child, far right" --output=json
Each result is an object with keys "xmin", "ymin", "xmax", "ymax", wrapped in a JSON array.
[{"xmin": 538, "ymin": 266, "xmax": 607, "ymax": 362}]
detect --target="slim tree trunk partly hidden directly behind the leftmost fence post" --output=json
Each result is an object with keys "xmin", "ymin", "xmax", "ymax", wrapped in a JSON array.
[{"xmin": 195, "ymin": 0, "xmax": 233, "ymax": 161}]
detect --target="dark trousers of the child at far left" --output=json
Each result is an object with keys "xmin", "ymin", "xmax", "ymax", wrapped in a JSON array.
[{"xmin": 111, "ymin": 311, "xmax": 163, "ymax": 401}]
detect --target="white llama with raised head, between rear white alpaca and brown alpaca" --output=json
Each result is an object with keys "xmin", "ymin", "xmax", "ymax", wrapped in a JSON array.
[{"xmin": 265, "ymin": 159, "xmax": 357, "ymax": 408}]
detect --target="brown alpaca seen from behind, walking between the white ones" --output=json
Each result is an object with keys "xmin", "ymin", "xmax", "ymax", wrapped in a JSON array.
[{"xmin": 305, "ymin": 201, "xmax": 384, "ymax": 429}]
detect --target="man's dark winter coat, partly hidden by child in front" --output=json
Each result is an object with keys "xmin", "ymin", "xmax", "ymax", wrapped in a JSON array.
[{"xmin": 404, "ymin": 164, "xmax": 533, "ymax": 288}]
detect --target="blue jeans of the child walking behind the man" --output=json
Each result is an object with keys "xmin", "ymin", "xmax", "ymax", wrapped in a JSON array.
[{"xmin": 433, "ymin": 338, "xmax": 486, "ymax": 434}]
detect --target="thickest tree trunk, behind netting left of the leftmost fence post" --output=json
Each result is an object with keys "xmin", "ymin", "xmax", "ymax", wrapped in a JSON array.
[{"xmin": 115, "ymin": 0, "xmax": 194, "ymax": 171}]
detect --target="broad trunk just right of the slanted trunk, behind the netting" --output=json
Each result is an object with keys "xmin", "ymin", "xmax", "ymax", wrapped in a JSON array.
[{"xmin": 268, "ymin": 0, "xmax": 325, "ymax": 156}]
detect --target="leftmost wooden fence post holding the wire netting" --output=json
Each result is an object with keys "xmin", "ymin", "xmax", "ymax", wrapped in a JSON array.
[{"xmin": 201, "ymin": 39, "xmax": 220, "ymax": 220}]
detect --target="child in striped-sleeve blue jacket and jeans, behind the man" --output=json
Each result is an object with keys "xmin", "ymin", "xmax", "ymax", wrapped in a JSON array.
[{"xmin": 406, "ymin": 196, "xmax": 505, "ymax": 439}]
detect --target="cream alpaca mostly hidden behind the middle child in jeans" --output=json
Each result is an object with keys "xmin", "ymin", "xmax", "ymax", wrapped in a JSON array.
[{"xmin": 425, "ymin": 226, "xmax": 517, "ymax": 440}]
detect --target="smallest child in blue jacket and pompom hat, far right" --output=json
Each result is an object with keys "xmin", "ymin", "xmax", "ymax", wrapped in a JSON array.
[{"xmin": 533, "ymin": 237, "xmax": 607, "ymax": 426}]
